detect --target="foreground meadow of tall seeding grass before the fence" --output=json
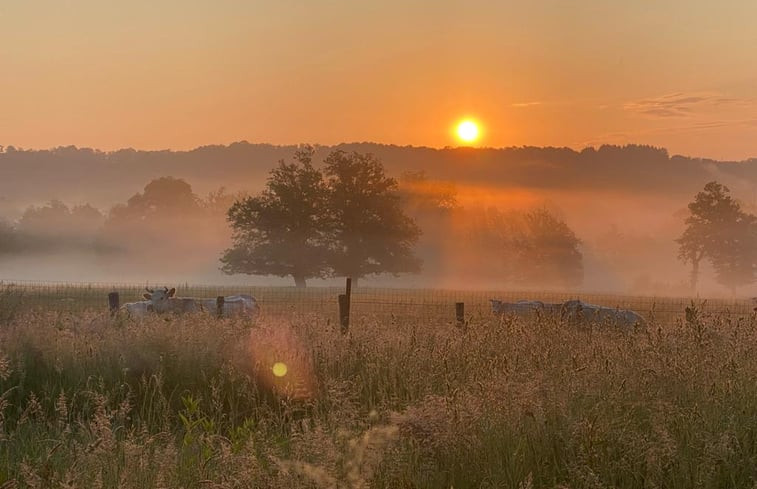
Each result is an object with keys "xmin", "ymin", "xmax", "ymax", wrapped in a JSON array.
[{"xmin": 0, "ymin": 290, "xmax": 757, "ymax": 489}]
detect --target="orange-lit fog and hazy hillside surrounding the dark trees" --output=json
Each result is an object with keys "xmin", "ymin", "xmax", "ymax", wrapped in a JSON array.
[{"xmin": 0, "ymin": 143, "xmax": 757, "ymax": 295}]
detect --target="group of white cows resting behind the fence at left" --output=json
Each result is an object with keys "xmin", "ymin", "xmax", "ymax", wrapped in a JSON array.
[{"xmin": 121, "ymin": 287, "xmax": 260, "ymax": 318}]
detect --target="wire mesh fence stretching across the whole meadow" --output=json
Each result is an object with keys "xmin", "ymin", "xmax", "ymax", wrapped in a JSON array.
[{"xmin": 0, "ymin": 280, "xmax": 756, "ymax": 321}]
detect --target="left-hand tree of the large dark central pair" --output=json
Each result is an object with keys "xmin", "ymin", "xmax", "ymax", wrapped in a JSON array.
[{"xmin": 221, "ymin": 147, "xmax": 329, "ymax": 287}]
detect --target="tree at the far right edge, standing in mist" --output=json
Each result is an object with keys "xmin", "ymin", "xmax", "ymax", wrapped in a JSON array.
[{"xmin": 676, "ymin": 182, "xmax": 757, "ymax": 291}]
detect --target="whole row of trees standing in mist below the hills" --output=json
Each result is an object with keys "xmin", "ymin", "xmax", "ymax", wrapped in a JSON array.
[{"xmin": 0, "ymin": 146, "xmax": 757, "ymax": 293}]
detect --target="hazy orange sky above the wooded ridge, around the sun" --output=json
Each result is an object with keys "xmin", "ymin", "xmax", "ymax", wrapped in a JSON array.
[{"xmin": 0, "ymin": 0, "xmax": 757, "ymax": 159}]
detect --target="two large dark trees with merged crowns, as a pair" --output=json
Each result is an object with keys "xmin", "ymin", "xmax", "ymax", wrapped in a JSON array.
[{"xmin": 221, "ymin": 147, "xmax": 420, "ymax": 286}]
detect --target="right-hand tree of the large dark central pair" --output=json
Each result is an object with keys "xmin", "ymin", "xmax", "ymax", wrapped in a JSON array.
[{"xmin": 324, "ymin": 151, "xmax": 421, "ymax": 283}]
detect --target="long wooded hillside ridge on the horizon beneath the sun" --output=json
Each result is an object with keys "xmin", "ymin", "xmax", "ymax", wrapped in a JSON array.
[{"xmin": 0, "ymin": 141, "xmax": 757, "ymax": 214}]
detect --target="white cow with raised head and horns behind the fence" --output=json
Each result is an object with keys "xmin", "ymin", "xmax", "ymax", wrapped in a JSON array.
[{"xmin": 144, "ymin": 287, "xmax": 260, "ymax": 317}]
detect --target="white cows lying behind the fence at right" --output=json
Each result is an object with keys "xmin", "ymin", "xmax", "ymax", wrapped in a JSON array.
[{"xmin": 490, "ymin": 299, "xmax": 646, "ymax": 329}]
